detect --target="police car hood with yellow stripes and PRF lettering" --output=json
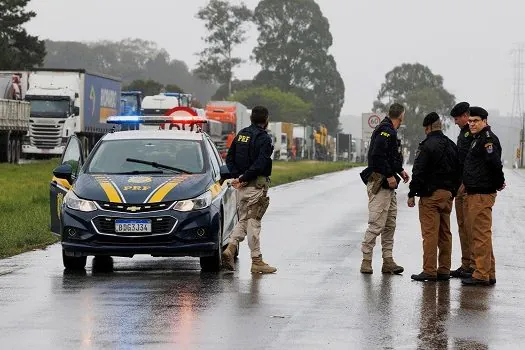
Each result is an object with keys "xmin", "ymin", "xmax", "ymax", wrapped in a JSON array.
[{"xmin": 73, "ymin": 174, "xmax": 211, "ymax": 204}]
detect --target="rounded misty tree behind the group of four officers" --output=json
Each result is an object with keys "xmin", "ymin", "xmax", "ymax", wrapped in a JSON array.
[{"xmin": 373, "ymin": 63, "xmax": 455, "ymax": 164}]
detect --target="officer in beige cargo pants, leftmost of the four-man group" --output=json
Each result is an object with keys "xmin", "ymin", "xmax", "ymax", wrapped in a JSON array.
[{"xmin": 360, "ymin": 103, "xmax": 409, "ymax": 274}]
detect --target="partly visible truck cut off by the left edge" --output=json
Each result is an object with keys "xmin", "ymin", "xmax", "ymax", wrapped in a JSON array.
[{"xmin": 0, "ymin": 72, "xmax": 31, "ymax": 163}]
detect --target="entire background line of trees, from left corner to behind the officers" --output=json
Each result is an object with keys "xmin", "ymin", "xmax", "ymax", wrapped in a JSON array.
[{"xmin": 0, "ymin": 0, "xmax": 455, "ymax": 146}]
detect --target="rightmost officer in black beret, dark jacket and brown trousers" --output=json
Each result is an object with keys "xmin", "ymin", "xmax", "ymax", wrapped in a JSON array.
[{"xmin": 461, "ymin": 107, "xmax": 505, "ymax": 285}]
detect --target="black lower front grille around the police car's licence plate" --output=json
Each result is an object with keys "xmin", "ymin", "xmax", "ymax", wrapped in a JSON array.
[{"xmin": 93, "ymin": 216, "xmax": 177, "ymax": 237}]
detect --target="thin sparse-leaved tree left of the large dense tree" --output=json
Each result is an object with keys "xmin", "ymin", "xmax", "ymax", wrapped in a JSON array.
[{"xmin": 195, "ymin": 0, "xmax": 252, "ymax": 95}]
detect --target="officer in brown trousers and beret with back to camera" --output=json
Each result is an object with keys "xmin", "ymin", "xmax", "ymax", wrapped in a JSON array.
[{"xmin": 408, "ymin": 112, "xmax": 460, "ymax": 281}]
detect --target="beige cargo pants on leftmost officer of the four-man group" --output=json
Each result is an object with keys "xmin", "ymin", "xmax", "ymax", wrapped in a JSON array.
[{"xmin": 361, "ymin": 181, "xmax": 397, "ymax": 260}]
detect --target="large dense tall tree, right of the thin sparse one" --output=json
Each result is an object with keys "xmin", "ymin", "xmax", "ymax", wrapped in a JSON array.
[{"xmin": 253, "ymin": 0, "xmax": 345, "ymax": 132}]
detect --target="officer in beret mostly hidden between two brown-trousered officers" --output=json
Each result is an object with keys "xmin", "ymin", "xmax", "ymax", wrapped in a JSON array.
[{"xmin": 450, "ymin": 102, "xmax": 476, "ymax": 278}]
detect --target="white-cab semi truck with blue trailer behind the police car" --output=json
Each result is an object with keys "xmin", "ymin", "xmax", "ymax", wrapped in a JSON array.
[{"xmin": 22, "ymin": 68, "xmax": 121, "ymax": 155}]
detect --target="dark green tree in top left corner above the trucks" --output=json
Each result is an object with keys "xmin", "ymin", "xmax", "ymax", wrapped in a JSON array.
[{"xmin": 0, "ymin": 0, "xmax": 46, "ymax": 69}]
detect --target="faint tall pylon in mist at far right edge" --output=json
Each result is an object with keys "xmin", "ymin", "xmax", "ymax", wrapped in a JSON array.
[{"xmin": 512, "ymin": 43, "xmax": 525, "ymax": 168}]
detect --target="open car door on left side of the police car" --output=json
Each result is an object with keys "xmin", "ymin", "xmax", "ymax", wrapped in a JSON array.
[{"xmin": 49, "ymin": 136, "xmax": 84, "ymax": 235}]
